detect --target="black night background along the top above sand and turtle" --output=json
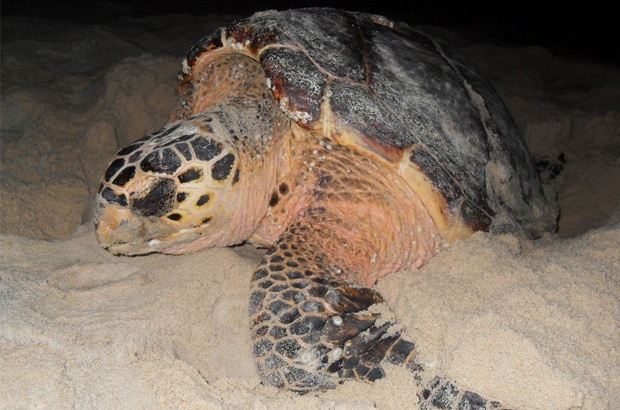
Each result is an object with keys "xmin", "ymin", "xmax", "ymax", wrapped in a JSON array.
[{"xmin": 0, "ymin": 0, "xmax": 620, "ymax": 64}]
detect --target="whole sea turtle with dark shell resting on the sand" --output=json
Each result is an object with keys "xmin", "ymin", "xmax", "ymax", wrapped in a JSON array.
[{"xmin": 95, "ymin": 9, "xmax": 556, "ymax": 409}]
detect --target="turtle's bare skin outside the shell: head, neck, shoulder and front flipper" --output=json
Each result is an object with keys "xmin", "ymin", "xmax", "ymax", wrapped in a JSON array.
[{"xmin": 95, "ymin": 49, "xmax": 512, "ymax": 409}]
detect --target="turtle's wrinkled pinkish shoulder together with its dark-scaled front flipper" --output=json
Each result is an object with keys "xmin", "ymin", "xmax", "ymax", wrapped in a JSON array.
[{"xmin": 249, "ymin": 137, "xmax": 512, "ymax": 409}]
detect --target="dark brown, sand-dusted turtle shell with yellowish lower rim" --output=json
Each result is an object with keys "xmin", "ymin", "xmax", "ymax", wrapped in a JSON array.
[{"xmin": 177, "ymin": 8, "xmax": 557, "ymax": 237}]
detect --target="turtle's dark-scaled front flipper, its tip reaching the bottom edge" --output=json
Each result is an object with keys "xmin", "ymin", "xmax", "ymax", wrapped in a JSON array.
[{"xmin": 249, "ymin": 232, "xmax": 502, "ymax": 410}]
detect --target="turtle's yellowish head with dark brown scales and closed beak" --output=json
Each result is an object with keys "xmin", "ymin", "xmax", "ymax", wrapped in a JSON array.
[{"xmin": 95, "ymin": 116, "xmax": 264, "ymax": 255}]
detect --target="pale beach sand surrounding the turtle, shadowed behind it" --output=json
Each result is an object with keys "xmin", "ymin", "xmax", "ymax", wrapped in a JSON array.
[{"xmin": 0, "ymin": 11, "xmax": 620, "ymax": 409}]
